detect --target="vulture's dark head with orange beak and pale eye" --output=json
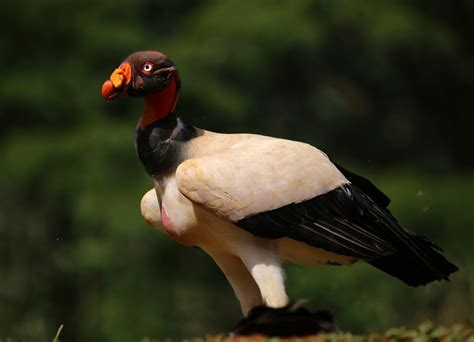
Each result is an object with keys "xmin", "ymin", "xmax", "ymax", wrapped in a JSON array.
[{"xmin": 102, "ymin": 51, "xmax": 180, "ymax": 101}]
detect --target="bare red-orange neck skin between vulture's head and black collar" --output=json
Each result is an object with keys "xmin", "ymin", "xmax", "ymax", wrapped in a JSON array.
[{"xmin": 140, "ymin": 74, "xmax": 179, "ymax": 130}]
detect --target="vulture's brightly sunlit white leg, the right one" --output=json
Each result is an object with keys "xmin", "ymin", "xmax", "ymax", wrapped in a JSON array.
[{"xmin": 240, "ymin": 239, "xmax": 288, "ymax": 308}]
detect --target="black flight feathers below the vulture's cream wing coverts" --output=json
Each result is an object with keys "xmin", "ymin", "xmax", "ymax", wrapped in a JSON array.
[{"xmin": 236, "ymin": 183, "xmax": 458, "ymax": 286}]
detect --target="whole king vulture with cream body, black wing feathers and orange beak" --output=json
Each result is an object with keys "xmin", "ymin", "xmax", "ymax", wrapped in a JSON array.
[{"xmin": 102, "ymin": 51, "xmax": 458, "ymax": 316}]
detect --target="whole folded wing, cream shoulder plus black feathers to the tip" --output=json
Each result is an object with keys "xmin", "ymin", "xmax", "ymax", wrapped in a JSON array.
[{"xmin": 176, "ymin": 137, "xmax": 457, "ymax": 286}]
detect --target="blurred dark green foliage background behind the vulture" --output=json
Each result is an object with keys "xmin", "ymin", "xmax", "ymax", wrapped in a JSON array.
[{"xmin": 0, "ymin": 0, "xmax": 474, "ymax": 341}]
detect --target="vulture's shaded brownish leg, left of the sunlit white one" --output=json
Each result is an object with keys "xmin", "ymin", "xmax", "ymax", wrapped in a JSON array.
[{"xmin": 205, "ymin": 250, "xmax": 262, "ymax": 316}]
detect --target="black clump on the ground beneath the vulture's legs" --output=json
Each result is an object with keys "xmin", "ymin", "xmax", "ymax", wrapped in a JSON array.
[{"xmin": 232, "ymin": 302, "xmax": 337, "ymax": 337}]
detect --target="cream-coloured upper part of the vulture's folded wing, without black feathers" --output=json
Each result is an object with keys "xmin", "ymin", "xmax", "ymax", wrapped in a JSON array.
[{"xmin": 176, "ymin": 136, "xmax": 348, "ymax": 222}]
